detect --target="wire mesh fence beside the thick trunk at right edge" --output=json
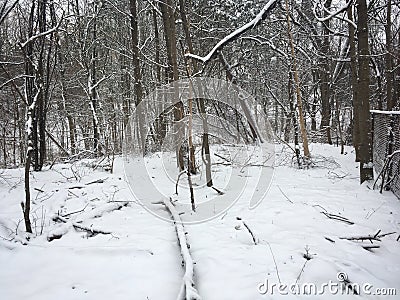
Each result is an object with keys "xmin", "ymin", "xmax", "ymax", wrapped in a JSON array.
[{"xmin": 371, "ymin": 110, "xmax": 400, "ymax": 199}]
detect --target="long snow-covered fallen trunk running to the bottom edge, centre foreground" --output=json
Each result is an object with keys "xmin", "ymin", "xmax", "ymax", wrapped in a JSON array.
[{"xmin": 163, "ymin": 199, "xmax": 201, "ymax": 300}]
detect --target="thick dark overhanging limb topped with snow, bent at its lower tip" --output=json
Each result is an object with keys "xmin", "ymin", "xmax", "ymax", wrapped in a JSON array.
[{"xmin": 185, "ymin": 0, "xmax": 279, "ymax": 64}]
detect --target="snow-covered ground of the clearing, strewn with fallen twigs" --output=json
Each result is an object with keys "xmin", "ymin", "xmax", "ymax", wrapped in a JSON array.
[{"xmin": 0, "ymin": 144, "xmax": 400, "ymax": 300}]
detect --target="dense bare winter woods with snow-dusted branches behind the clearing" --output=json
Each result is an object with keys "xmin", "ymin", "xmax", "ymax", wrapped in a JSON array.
[{"xmin": 0, "ymin": 0, "xmax": 400, "ymax": 230}]
